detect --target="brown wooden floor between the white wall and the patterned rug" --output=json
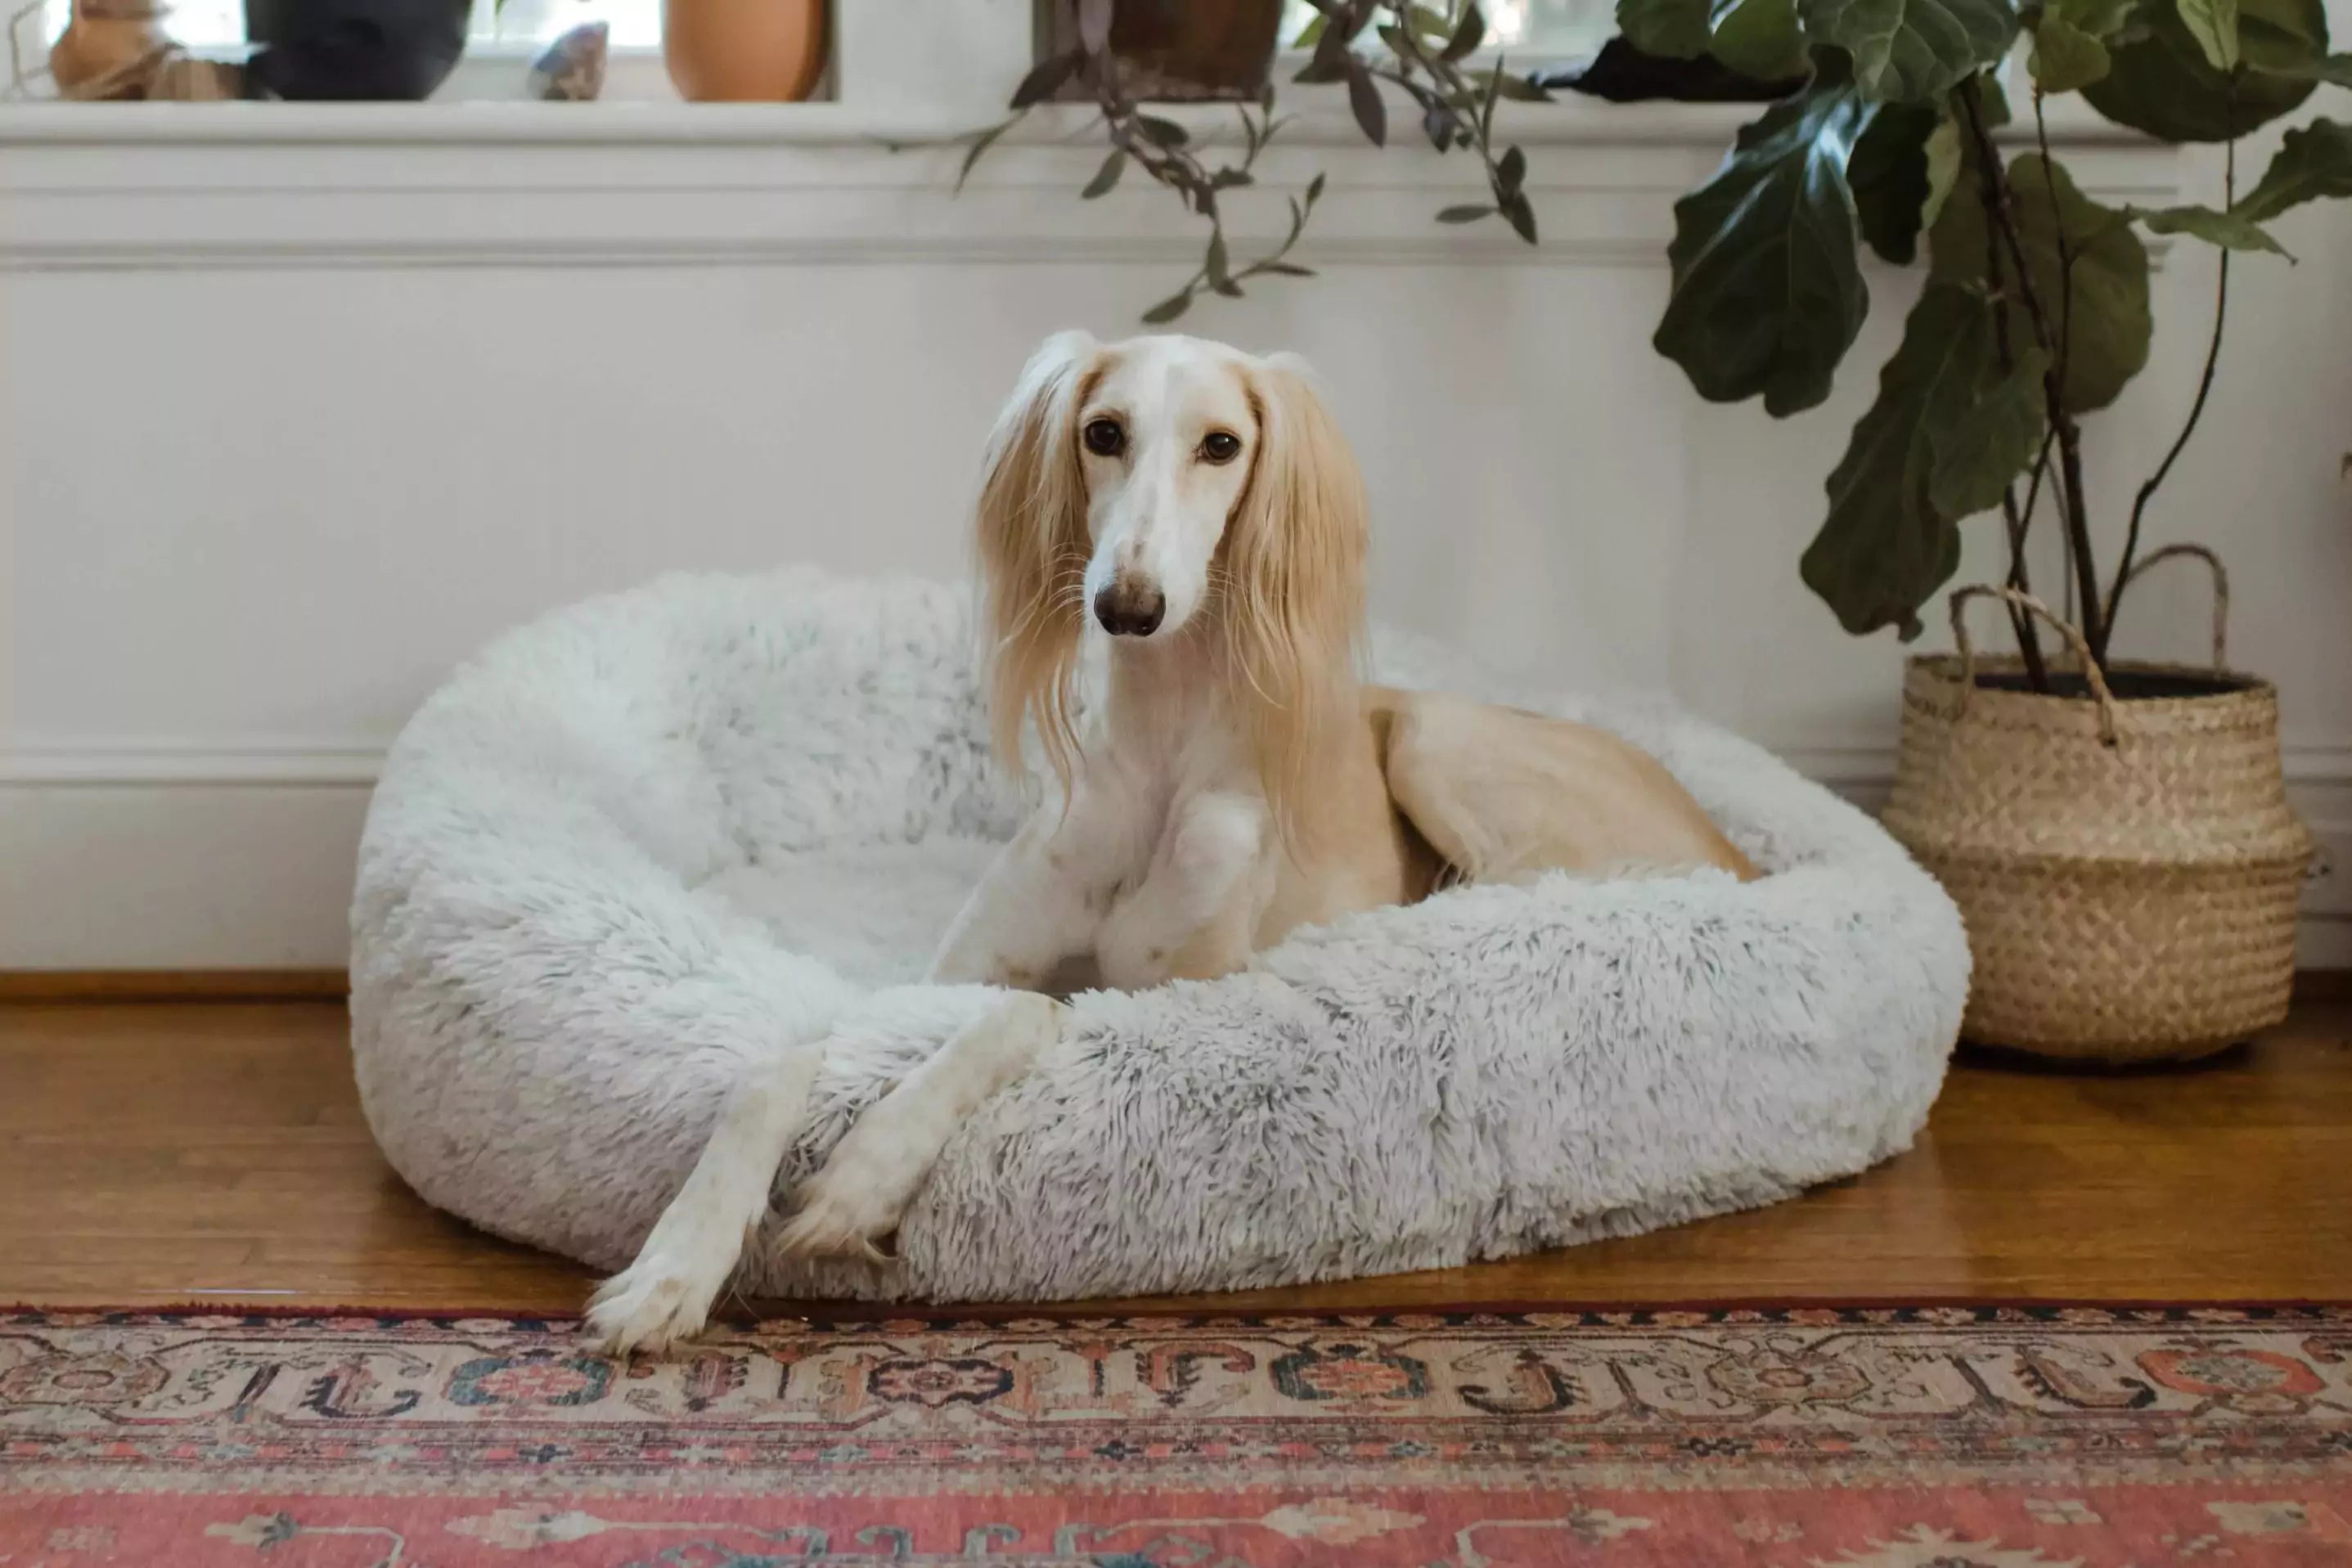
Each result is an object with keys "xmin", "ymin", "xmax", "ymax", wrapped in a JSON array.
[{"xmin": 0, "ymin": 1001, "xmax": 2352, "ymax": 1312}]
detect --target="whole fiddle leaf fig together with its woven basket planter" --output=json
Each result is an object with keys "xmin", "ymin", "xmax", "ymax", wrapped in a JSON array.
[{"xmin": 1618, "ymin": 0, "xmax": 2352, "ymax": 1060}]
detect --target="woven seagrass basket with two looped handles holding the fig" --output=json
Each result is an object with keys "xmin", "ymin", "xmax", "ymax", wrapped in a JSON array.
[{"xmin": 1884, "ymin": 546, "xmax": 2312, "ymax": 1063}]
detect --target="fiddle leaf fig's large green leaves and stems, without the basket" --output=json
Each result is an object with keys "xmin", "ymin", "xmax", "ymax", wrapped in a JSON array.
[{"xmin": 1616, "ymin": 0, "xmax": 2352, "ymax": 691}]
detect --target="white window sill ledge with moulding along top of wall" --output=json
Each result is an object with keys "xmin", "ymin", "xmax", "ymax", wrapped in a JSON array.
[{"xmin": 0, "ymin": 77, "xmax": 2180, "ymax": 271}]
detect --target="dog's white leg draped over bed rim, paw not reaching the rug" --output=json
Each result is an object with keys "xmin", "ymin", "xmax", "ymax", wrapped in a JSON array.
[{"xmin": 776, "ymin": 992, "xmax": 1068, "ymax": 1262}]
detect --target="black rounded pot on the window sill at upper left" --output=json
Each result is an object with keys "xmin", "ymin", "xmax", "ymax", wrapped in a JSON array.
[{"xmin": 245, "ymin": 0, "xmax": 470, "ymax": 103}]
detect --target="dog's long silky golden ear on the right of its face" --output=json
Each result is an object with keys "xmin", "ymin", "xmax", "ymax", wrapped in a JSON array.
[{"xmin": 1223, "ymin": 355, "xmax": 1369, "ymax": 849}]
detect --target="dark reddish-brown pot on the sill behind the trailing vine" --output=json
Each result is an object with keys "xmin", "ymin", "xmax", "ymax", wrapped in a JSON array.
[{"xmin": 1037, "ymin": 0, "xmax": 1282, "ymax": 103}]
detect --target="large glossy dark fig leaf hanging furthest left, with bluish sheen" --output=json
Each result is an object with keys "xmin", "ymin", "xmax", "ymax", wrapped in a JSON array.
[{"xmin": 1651, "ymin": 56, "xmax": 1870, "ymax": 419}]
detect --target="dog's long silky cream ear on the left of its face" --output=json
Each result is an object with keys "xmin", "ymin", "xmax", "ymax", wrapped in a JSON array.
[{"xmin": 976, "ymin": 331, "xmax": 1099, "ymax": 788}]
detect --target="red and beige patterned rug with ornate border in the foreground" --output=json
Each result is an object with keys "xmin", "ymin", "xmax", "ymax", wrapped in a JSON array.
[{"xmin": 0, "ymin": 1307, "xmax": 2352, "ymax": 1568}]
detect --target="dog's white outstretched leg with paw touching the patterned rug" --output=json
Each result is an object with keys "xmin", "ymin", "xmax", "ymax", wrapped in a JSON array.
[{"xmin": 588, "ymin": 1041, "xmax": 823, "ymax": 1354}]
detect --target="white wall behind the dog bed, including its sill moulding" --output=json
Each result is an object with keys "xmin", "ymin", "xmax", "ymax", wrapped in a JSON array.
[{"xmin": 0, "ymin": 85, "xmax": 2352, "ymax": 968}]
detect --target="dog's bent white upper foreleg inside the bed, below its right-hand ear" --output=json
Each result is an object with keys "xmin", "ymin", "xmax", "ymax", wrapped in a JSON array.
[{"xmin": 1096, "ymin": 790, "xmax": 1279, "ymax": 990}]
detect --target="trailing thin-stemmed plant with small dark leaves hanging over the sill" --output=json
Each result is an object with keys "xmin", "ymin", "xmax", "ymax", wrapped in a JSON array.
[{"xmin": 955, "ymin": 0, "xmax": 1550, "ymax": 326}]
